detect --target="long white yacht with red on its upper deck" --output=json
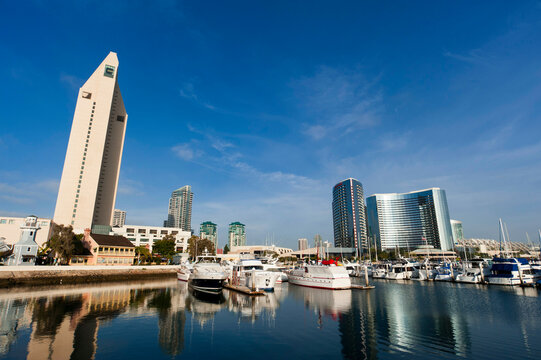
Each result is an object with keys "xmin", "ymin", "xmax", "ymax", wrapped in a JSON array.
[{"xmin": 288, "ymin": 260, "xmax": 351, "ymax": 290}]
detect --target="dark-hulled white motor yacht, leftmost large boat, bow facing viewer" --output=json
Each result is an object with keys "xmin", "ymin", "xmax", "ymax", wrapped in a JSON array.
[{"xmin": 188, "ymin": 254, "xmax": 227, "ymax": 294}]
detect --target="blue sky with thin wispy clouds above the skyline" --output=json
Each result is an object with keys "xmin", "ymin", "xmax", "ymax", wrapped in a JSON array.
[{"xmin": 0, "ymin": 0, "xmax": 541, "ymax": 248}]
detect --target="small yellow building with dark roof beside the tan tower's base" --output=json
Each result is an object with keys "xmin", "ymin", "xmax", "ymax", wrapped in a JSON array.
[{"xmin": 70, "ymin": 230, "xmax": 135, "ymax": 265}]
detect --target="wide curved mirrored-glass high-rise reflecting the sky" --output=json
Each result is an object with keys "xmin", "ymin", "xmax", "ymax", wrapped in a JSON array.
[{"xmin": 366, "ymin": 188, "xmax": 453, "ymax": 251}]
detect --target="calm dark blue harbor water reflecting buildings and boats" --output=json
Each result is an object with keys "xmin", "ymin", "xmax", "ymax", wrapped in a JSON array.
[{"xmin": 0, "ymin": 280, "xmax": 541, "ymax": 360}]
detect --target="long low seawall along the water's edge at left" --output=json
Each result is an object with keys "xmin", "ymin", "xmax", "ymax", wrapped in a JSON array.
[{"xmin": 0, "ymin": 265, "xmax": 178, "ymax": 288}]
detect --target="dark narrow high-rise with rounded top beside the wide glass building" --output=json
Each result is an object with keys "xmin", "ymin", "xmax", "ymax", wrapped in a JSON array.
[{"xmin": 332, "ymin": 178, "xmax": 367, "ymax": 253}]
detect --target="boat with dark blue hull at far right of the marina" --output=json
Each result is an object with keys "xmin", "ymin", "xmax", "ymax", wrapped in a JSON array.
[{"xmin": 487, "ymin": 258, "xmax": 535, "ymax": 286}]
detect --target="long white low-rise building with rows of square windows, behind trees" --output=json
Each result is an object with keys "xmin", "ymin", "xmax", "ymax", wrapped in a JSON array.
[{"xmin": 109, "ymin": 225, "xmax": 192, "ymax": 252}]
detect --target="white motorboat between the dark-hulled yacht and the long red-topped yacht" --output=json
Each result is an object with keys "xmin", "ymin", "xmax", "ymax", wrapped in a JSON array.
[{"xmin": 229, "ymin": 259, "xmax": 281, "ymax": 291}]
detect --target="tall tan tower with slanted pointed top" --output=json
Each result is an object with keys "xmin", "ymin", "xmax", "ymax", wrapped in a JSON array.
[{"xmin": 53, "ymin": 52, "xmax": 128, "ymax": 232}]
